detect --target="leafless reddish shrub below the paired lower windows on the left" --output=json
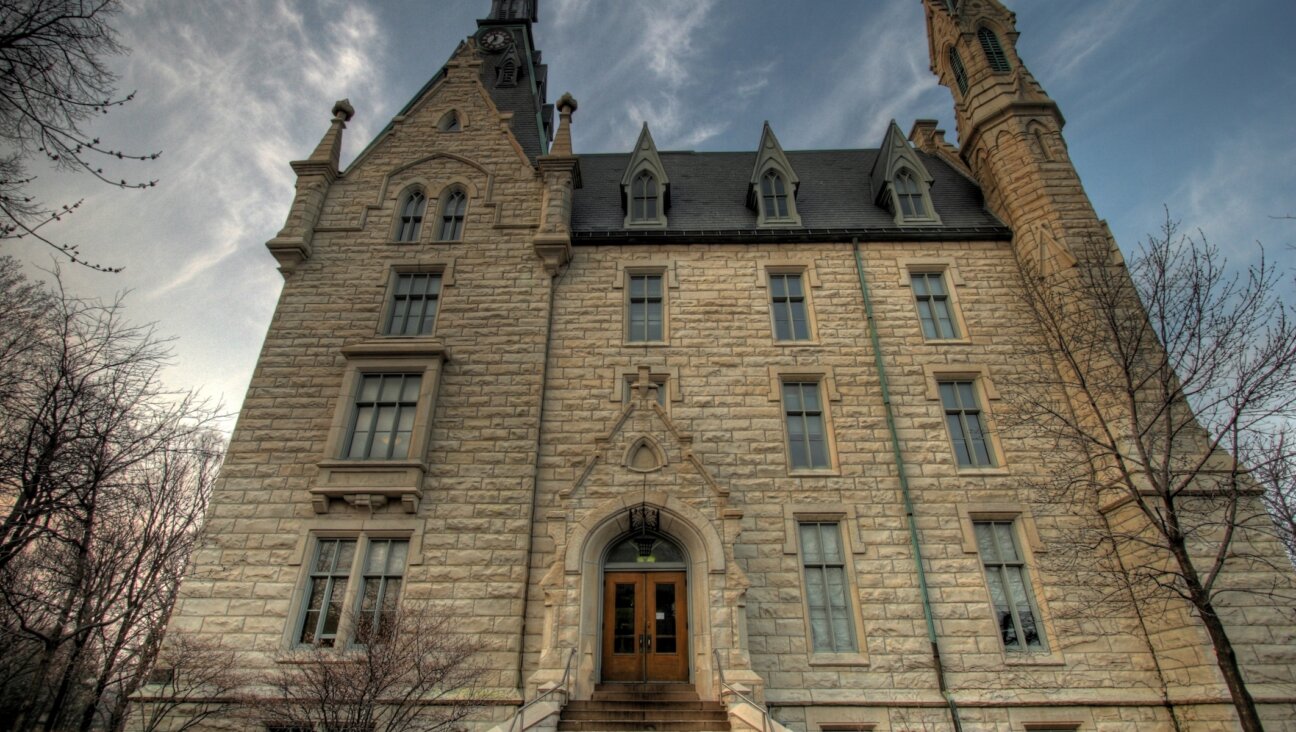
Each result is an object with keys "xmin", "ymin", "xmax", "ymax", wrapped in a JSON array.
[{"xmin": 251, "ymin": 606, "xmax": 487, "ymax": 732}]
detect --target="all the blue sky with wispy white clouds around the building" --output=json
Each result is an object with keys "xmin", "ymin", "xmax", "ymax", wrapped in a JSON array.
[{"xmin": 12, "ymin": 0, "xmax": 1296, "ymax": 424}]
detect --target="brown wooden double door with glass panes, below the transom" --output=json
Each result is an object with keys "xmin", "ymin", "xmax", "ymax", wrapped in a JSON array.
[{"xmin": 603, "ymin": 571, "xmax": 688, "ymax": 681}]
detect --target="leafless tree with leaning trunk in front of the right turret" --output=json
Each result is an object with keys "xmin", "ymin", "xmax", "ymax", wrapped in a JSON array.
[{"xmin": 1013, "ymin": 216, "xmax": 1296, "ymax": 731}]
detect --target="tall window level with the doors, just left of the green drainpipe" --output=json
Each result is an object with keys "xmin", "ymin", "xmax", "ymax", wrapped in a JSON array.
[{"xmin": 798, "ymin": 522, "xmax": 855, "ymax": 653}]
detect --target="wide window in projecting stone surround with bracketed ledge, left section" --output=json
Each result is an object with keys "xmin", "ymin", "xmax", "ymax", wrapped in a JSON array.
[{"xmin": 343, "ymin": 373, "xmax": 422, "ymax": 460}]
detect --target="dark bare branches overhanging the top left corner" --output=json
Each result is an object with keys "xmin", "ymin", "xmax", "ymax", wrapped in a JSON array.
[{"xmin": 0, "ymin": 0, "xmax": 158, "ymax": 271}]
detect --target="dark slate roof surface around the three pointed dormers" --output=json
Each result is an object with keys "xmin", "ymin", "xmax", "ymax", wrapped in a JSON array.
[{"xmin": 572, "ymin": 149, "xmax": 1010, "ymax": 244}]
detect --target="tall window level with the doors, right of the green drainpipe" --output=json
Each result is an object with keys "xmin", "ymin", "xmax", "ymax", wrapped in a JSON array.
[{"xmin": 972, "ymin": 521, "xmax": 1046, "ymax": 652}]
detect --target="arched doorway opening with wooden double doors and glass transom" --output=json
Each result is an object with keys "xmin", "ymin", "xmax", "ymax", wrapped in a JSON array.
[{"xmin": 600, "ymin": 531, "xmax": 689, "ymax": 683}]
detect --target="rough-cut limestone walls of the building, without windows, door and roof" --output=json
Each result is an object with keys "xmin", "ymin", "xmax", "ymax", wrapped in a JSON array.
[{"xmin": 171, "ymin": 0, "xmax": 1296, "ymax": 732}]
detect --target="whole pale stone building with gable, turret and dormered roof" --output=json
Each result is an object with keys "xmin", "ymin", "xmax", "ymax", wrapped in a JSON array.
[{"xmin": 171, "ymin": 0, "xmax": 1296, "ymax": 732}]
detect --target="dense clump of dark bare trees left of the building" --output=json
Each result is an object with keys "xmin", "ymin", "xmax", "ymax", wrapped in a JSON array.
[{"xmin": 0, "ymin": 258, "xmax": 223, "ymax": 731}]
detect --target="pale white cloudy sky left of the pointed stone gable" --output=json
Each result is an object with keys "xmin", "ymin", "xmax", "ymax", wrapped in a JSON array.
[{"xmin": 10, "ymin": 0, "xmax": 384, "ymax": 422}]
